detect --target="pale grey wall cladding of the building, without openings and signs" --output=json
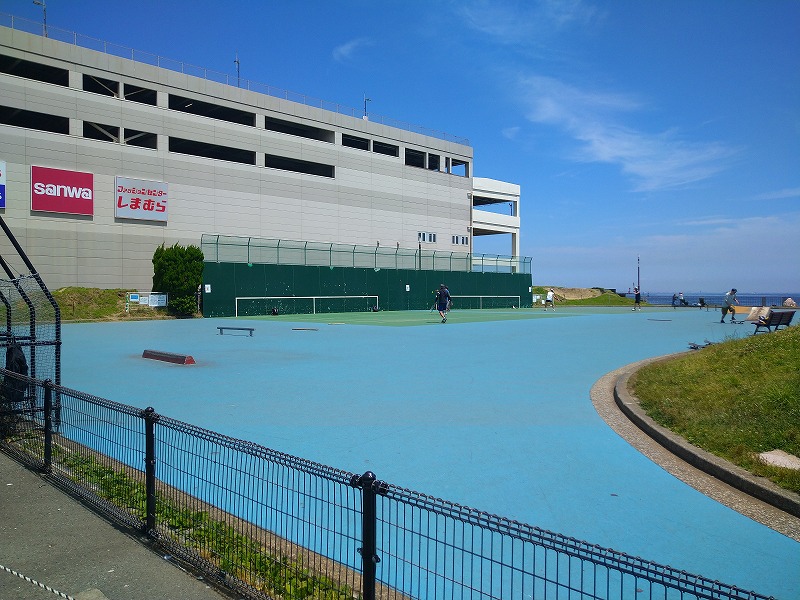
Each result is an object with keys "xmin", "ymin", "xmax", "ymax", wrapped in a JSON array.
[{"xmin": 0, "ymin": 27, "xmax": 482, "ymax": 289}]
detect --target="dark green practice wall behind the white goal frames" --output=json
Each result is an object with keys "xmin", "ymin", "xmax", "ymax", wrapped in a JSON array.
[{"xmin": 203, "ymin": 262, "xmax": 532, "ymax": 317}]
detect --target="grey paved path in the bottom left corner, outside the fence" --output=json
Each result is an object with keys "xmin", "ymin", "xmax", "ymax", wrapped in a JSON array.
[{"xmin": 0, "ymin": 452, "xmax": 234, "ymax": 600}]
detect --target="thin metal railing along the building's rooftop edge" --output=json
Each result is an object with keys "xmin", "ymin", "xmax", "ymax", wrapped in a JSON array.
[{"xmin": 0, "ymin": 13, "xmax": 469, "ymax": 146}]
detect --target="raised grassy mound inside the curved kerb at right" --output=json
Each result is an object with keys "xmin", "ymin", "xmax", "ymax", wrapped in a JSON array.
[{"xmin": 631, "ymin": 327, "xmax": 800, "ymax": 493}]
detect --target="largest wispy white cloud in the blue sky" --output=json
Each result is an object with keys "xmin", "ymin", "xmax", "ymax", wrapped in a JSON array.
[{"xmin": 520, "ymin": 76, "xmax": 736, "ymax": 191}]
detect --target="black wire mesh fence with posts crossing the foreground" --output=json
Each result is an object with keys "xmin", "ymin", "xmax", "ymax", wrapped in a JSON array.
[{"xmin": 0, "ymin": 369, "xmax": 776, "ymax": 600}]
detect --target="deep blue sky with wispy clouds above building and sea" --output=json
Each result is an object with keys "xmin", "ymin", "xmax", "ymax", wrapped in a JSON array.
[{"xmin": 6, "ymin": 0, "xmax": 800, "ymax": 293}]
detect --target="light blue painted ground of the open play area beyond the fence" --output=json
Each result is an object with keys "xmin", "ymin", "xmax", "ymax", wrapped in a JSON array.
[{"xmin": 62, "ymin": 307, "xmax": 800, "ymax": 600}]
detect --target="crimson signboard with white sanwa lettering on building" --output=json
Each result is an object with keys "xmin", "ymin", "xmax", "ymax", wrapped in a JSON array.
[{"xmin": 31, "ymin": 166, "xmax": 94, "ymax": 215}]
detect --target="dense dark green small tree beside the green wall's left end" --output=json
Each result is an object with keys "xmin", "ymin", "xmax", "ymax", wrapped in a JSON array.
[{"xmin": 153, "ymin": 244, "xmax": 203, "ymax": 315}]
